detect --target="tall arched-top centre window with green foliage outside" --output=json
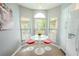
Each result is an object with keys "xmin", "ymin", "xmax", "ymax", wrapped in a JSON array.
[{"xmin": 33, "ymin": 12, "xmax": 46, "ymax": 34}]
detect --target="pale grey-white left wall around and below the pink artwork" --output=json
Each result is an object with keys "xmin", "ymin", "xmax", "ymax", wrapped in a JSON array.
[{"xmin": 0, "ymin": 4, "xmax": 21, "ymax": 56}]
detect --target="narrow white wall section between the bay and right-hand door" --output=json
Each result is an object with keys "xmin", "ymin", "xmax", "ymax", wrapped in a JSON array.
[{"xmin": 60, "ymin": 5, "xmax": 68, "ymax": 49}]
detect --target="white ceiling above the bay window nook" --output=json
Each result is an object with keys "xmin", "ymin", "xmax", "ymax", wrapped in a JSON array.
[{"xmin": 19, "ymin": 3, "xmax": 61, "ymax": 10}]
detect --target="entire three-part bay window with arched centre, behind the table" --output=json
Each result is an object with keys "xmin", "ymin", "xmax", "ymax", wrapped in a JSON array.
[{"xmin": 21, "ymin": 13, "xmax": 58, "ymax": 41}]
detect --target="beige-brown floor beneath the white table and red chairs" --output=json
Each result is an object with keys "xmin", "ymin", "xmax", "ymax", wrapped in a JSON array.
[{"xmin": 15, "ymin": 44, "xmax": 65, "ymax": 56}]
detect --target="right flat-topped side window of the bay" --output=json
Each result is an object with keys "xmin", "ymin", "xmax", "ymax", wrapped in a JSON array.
[{"xmin": 49, "ymin": 17, "xmax": 57, "ymax": 41}]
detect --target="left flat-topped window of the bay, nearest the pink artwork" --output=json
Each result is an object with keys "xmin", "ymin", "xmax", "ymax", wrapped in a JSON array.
[{"xmin": 21, "ymin": 17, "xmax": 30, "ymax": 41}]
